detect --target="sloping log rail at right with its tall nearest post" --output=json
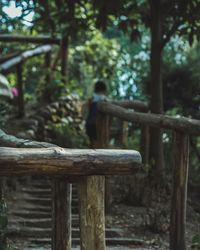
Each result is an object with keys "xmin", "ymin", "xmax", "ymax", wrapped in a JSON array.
[{"xmin": 98, "ymin": 102, "xmax": 200, "ymax": 250}]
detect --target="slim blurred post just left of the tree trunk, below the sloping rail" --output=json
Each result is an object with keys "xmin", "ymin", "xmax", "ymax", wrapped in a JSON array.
[{"xmin": 140, "ymin": 125, "xmax": 149, "ymax": 165}]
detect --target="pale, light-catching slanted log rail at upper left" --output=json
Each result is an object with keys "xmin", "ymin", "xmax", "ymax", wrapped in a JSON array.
[{"xmin": 0, "ymin": 45, "xmax": 52, "ymax": 71}]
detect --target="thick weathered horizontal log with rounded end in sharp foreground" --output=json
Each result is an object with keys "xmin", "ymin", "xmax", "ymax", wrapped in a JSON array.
[{"xmin": 0, "ymin": 147, "xmax": 141, "ymax": 176}]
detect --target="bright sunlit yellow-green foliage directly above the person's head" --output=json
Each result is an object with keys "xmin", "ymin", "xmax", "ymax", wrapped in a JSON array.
[{"xmin": 69, "ymin": 31, "xmax": 119, "ymax": 96}]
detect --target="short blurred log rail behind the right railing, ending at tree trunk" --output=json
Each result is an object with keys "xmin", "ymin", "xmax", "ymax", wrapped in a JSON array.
[{"xmin": 111, "ymin": 100, "xmax": 149, "ymax": 112}]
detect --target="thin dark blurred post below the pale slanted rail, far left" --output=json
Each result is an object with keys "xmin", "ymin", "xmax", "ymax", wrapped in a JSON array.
[{"xmin": 17, "ymin": 63, "xmax": 24, "ymax": 117}]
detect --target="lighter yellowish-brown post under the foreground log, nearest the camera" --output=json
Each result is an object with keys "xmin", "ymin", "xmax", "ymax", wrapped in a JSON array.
[{"xmin": 79, "ymin": 176, "xmax": 106, "ymax": 250}]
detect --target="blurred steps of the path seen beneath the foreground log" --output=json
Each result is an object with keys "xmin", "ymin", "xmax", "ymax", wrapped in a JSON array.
[{"xmin": 8, "ymin": 177, "xmax": 144, "ymax": 250}]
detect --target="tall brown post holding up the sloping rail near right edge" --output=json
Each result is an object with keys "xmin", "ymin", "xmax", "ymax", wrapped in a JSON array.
[{"xmin": 170, "ymin": 132, "xmax": 189, "ymax": 250}]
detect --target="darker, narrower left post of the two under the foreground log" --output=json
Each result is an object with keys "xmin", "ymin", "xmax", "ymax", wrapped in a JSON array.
[{"xmin": 52, "ymin": 179, "xmax": 71, "ymax": 250}]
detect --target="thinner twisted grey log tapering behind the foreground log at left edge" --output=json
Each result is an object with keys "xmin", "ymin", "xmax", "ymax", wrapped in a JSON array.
[{"xmin": 0, "ymin": 129, "xmax": 56, "ymax": 149}]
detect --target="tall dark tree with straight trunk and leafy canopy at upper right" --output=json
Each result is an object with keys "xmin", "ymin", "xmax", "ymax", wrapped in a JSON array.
[{"xmin": 93, "ymin": 0, "xmax": 200, "ymax": 180}]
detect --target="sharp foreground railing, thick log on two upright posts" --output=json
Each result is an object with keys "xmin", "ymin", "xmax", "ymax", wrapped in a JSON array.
[{"xmin": 0, "ymin": 146, "xmax": 141, "ymax": 250}]
